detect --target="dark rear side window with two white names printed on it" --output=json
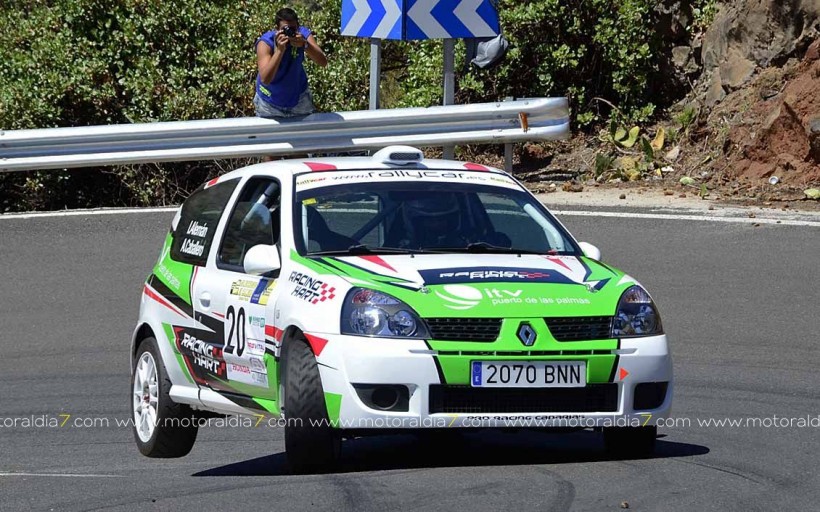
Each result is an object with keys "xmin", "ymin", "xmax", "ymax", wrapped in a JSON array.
[{"xmin": 171, "ymin": 180, "xmax": 237, "ymax": 266}]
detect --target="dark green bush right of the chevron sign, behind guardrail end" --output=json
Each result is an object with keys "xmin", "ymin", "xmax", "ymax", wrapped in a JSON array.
[{"xmin": 461, "ymin": 0, "xmax": 661, "ymax": 125}]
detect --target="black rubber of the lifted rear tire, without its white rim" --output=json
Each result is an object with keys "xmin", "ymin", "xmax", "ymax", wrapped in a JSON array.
[{"xmin": 131, "ymin": 338, "xmax": 198, "ymax": 458}]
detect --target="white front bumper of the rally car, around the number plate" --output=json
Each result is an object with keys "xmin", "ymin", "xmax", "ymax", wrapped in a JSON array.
[{"xmin": 310, "ymin": 334, "xmax": 673, "ymax": 430}]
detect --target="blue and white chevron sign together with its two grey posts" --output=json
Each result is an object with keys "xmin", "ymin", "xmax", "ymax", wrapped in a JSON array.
[{"xmin": 341, "ymin": 0, "xmax": 500, "ymax": 152}]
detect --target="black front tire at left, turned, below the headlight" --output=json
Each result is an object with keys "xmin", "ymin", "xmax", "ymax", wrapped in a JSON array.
[{"xmin": 282, "ymin": 338, "xmax": 341, "ymax": 473}]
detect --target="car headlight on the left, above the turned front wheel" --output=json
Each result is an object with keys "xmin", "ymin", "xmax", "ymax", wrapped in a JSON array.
[{"xmin": 341, "ymin": 288, "xmax": 430, "ymax": 338}]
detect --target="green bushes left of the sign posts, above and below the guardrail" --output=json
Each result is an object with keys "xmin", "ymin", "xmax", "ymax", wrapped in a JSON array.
[{"xmin": 0, "ymin": 0, "xmax": 368, "ymax": 211}]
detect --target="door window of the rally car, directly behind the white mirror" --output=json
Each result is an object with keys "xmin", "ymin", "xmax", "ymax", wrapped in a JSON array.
[{"xmin": 216, "ymin": 177, "xmax": 281, "ymax": 272}]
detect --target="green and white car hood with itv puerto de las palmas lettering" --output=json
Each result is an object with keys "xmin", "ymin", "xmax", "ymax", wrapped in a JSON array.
[{"xmin": 306, "ymin": 254, "xmax": 636, "ymax": 318}]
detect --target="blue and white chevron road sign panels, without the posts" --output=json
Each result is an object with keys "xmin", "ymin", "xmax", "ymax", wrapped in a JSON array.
[{"xmin": 342, "ymin": 0, "xmax": 499, "ymax": 40}]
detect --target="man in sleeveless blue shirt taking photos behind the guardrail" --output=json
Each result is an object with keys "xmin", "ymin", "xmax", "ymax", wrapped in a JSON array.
[{"xmin": 253, "ymin": 7, "xmax": 327, "ymax": 117}]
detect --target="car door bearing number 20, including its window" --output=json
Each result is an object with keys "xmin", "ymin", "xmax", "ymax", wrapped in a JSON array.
[{"xmin": 193, "ymin": 176, "xmax": 281, "ymax": 406}]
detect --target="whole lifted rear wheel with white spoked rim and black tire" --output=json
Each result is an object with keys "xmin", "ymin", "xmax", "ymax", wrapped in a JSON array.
[{"xmin": 131, "ymin": 338, "xmax": 197, "ymax": 458}]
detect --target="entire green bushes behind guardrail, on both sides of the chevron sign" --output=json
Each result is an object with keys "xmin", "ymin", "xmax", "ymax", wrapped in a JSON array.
[{"xmin": 0, "ymin": 0, "xmax": 714, "ymax": 210}]
